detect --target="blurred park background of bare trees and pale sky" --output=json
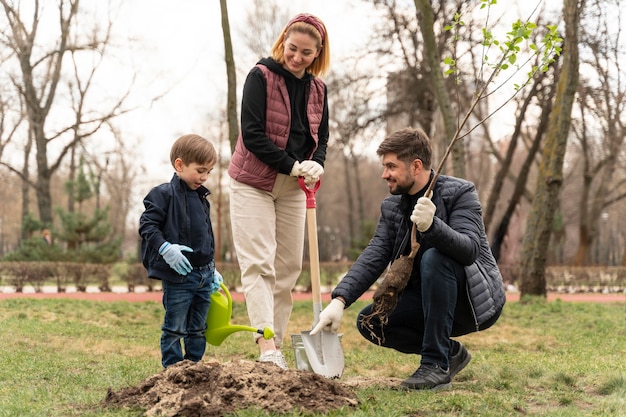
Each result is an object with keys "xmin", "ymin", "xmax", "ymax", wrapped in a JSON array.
[{"xmin": 0, "ymin": 0, "xmax": 626, "ymax": 293}]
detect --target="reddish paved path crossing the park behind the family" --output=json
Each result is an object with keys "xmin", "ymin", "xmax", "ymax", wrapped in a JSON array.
[{"xmin": 0, "ymin": 291, "xmax": 626, "ymax": 303}]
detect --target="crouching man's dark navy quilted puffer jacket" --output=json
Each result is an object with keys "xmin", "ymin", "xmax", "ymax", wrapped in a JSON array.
[{"xmin": 332, "ymin": 173, "xmax": 506, "ymax": 329}]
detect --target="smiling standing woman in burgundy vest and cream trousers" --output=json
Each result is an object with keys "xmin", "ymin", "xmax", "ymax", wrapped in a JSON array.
[{"xmin": 228, "ymin": 14, "xmax": 330, "ymax": 369}]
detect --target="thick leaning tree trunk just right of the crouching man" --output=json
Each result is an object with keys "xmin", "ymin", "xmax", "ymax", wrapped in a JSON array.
[{"xmin": 520, "ymin": 0, "xmax": 584, "ymax": 297}]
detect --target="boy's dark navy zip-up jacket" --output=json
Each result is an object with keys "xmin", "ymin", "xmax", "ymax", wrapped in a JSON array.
[{"xmin": 139, "ymin": 174, "xmax": 215, "ymax": 282}]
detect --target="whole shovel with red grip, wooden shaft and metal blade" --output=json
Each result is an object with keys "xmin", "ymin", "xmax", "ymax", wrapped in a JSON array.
[{"xmin": 298, "ymin": 177, "xmax": 344, "ymax": 378}]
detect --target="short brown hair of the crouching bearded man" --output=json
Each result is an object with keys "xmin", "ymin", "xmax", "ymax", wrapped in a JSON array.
[{"xmin": 376, "ymin": 127, "xmax": 433, "ymax": 169}]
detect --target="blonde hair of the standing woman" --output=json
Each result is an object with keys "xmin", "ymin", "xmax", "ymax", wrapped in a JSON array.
[{"xmin": 272, "ymin": 14, "xmax": 330, "ymax": 77}]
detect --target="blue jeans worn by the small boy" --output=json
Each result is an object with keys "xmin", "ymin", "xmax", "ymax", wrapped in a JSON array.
[{"xmin": 161, "ymin": 264, "xmax": 215, "ymax": 368}]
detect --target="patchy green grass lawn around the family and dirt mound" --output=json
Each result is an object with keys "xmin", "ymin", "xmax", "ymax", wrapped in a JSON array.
[{"xmin": 0, "ymin": 298, "xmax": 626, "ymax": 417}]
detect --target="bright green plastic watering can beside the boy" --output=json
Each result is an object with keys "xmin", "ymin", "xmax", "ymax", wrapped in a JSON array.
[{"xmin": 205, "ymin": 283, "xmax": 274, "ymax": 346}]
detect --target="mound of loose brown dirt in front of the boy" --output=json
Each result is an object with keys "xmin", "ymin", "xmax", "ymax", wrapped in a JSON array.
[{"xmin": 104, "ymin": 360, "xmax": 357, "ymax": 417}]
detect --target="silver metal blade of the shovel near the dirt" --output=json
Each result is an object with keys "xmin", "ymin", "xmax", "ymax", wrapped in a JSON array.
[{"xmin": 302, "ymin": 330, "xmax": 344, "ymax": 379}]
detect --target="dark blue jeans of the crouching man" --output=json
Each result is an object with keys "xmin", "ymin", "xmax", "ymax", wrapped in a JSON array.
[{"xmin": 357, "ymin": 248, "xmax": 476, "ymax": 369}]
